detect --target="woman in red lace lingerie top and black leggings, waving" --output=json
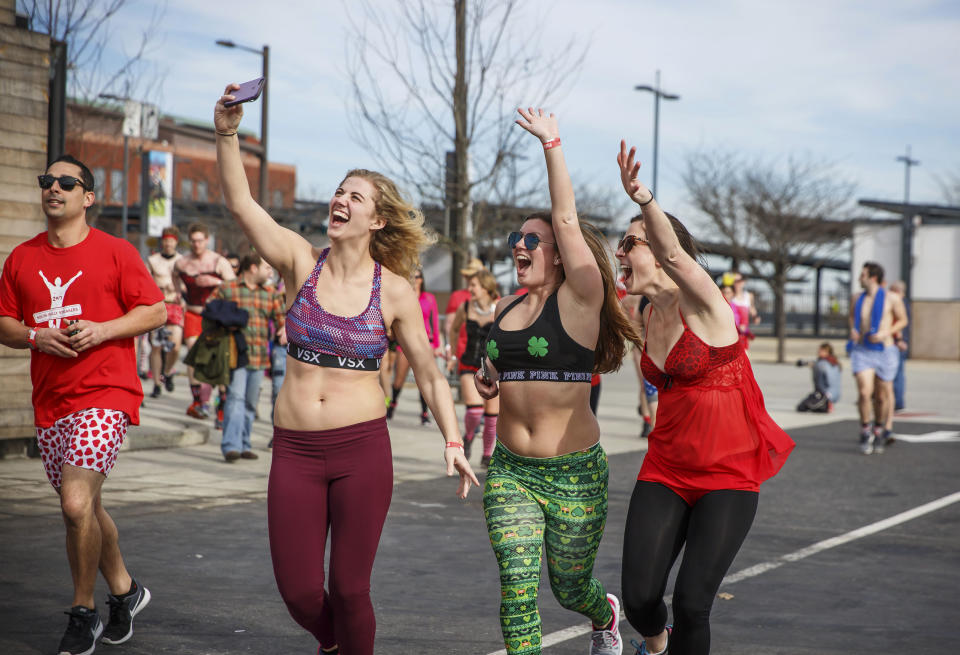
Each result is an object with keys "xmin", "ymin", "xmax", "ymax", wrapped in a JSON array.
[{"xmin": 617, "ymin": 141, "xmax": 794, "ymax": 655}]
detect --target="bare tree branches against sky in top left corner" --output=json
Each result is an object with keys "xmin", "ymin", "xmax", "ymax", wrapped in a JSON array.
[{"xmin": 17, "ymin": 0, "xmax": 164, "ymax": 102}]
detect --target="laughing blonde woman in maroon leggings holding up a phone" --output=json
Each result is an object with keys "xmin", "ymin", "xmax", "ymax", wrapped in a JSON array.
[{"xmin": 214, "ymin": 84, "xmax": 479, "ymax": 655}]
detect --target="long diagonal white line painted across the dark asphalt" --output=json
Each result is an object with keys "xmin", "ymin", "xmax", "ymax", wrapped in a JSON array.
[{"xmin": 488, "ymin": 490, "xmax": 960, "ymax": 655}]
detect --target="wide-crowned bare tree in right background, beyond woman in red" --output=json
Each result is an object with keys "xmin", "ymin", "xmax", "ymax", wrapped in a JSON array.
[{"xmin": 683, "ymin": 150, "xmax": 854, "ymax": 362}]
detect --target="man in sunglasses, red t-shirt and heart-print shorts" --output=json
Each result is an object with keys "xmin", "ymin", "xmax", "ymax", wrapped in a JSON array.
[{"xmin": 0, "ymin": 155, "xmax": 167, "ymax": 654}]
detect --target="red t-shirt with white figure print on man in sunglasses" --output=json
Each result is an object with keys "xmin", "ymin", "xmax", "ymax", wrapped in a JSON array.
[{"xmin": 0, "ymin": 228, "xmax": 163, "ymax": 427}]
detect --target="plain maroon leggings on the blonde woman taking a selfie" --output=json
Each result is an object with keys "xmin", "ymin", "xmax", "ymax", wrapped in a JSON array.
[{"xmin": 267, "ymin": 418, "xmax": 393, "ymax": 655}]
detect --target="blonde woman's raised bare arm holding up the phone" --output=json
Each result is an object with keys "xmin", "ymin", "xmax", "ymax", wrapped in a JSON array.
[{"xmin": 213, "ymin": 84, "xmax": 313, "ymax": 280}]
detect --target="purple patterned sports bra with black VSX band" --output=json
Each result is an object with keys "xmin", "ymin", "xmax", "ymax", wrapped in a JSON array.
[{"xmin": 286, "ymin": 248, "xmax": 388, "ymax": 371}]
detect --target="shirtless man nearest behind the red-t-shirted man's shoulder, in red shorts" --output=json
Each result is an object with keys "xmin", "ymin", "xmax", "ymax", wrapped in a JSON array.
[{"xmin": 147, "ymin": 225, "xmax": 183, "ymax": 398}]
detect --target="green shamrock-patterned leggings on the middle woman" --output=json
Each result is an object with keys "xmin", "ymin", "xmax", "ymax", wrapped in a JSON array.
[{"xmin": 483, "ymin": 443, "xmax": 613, "ymax": 655}]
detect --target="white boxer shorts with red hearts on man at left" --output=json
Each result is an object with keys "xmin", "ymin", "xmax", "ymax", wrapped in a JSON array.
[{"xmin": 37, "ymin": 408, "xmax": 130, "ymax": 489}]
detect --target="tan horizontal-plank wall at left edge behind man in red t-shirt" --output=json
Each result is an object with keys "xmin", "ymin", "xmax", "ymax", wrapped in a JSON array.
[{"xmin": 0, "ymin": 0, "xmax": 50, "ymax": 439}]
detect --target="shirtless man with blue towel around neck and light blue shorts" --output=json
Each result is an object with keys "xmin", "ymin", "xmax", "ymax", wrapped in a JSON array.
[{"xmin": 848, "ymin": 262, "xmax": 908, "ymax": 455}]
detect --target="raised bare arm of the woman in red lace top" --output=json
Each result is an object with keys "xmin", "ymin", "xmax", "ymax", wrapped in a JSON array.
[{"xmin": 617, "ymin": 141, "xmax": 732, "ymax": 325}]
